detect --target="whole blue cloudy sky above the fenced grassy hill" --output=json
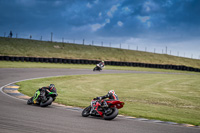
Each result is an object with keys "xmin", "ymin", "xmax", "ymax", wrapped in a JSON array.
[{"xmin": 0, "ymin": 0, "xmax": 200, "ymax": 59}]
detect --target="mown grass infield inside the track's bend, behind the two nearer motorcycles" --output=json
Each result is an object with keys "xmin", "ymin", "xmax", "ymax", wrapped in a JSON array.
[{"xmin": 17, "ymin": 74, "xmax": 200, "ymax": 125}]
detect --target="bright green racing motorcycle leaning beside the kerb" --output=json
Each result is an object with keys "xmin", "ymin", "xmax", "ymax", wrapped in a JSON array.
[{"xmin": 27, "ymin": 90, "xmax": 58, "ymax": 107}]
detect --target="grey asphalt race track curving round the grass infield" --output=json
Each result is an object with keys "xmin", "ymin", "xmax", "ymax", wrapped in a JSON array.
[{"xmin": 0, "ymin": 68, "xmax": 200, "ymax": 133}]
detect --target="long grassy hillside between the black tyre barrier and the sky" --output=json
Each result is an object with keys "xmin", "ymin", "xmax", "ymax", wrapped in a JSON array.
[{"xmin": 0, "ymin": 37, "xmax": 200, "ymax": 68}]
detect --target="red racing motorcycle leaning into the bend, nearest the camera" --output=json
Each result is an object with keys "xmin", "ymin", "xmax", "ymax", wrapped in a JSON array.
[{"xmin": 82, "ymin": 99, "xmax": 124, "ymax": 120}]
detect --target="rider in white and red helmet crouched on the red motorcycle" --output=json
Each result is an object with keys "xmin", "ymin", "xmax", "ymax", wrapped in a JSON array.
[{"xmin": 94, "ymin": 90, "xmax": 119, "ymax": 107}]
